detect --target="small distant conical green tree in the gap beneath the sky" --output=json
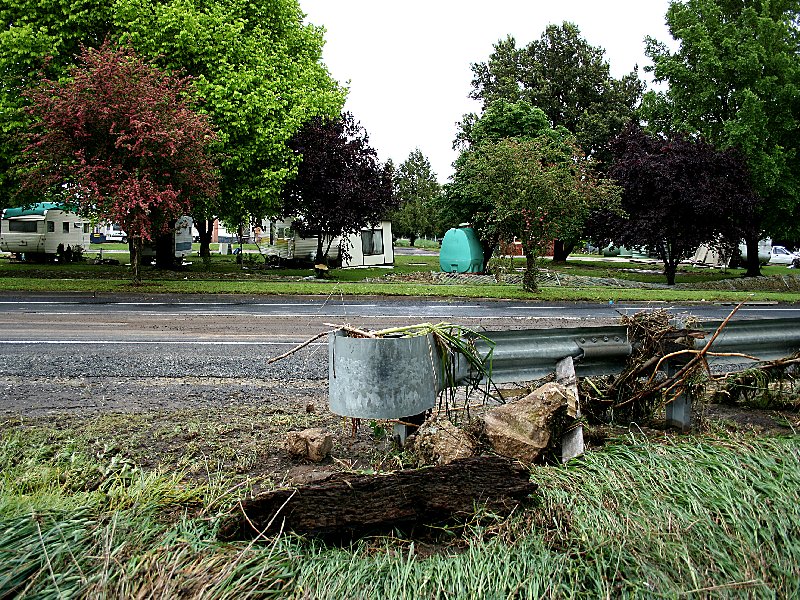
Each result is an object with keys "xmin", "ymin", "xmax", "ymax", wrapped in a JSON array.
[{"xmin": 390, "ymin": 148, "xmax": 442, "ymax": 246}]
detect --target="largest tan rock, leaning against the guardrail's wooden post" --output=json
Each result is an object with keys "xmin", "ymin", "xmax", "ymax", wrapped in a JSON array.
[{"xmin": 483, "ymin": 383, "xmax": 570, "ymax": 464}]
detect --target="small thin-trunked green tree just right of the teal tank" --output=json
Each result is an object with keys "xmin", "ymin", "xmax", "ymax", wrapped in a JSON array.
[{"xmin": 466, "ymin": 135, "xmax": 619, "ymax": 292}]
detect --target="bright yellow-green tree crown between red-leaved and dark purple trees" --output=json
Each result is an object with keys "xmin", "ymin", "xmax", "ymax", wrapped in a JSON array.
[{"xmin": 114, "ymin": 0, "xmax": 344, "ymax": 230}]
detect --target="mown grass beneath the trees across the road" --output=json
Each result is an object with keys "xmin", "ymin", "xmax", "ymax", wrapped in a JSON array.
[{"xmin": 0, "ymin": 250, "xmax": 800, "ymax": 303}]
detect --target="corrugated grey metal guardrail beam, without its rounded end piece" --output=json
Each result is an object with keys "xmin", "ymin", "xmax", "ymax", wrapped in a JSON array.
[{"xmin": 477, "ymin": 319, "xmax": 800, "ymax": 383}]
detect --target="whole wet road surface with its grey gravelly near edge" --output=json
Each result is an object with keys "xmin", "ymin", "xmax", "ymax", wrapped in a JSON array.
[{"xmin": 0, "ymin": 294, "xmax": 800, "ymax": 414}]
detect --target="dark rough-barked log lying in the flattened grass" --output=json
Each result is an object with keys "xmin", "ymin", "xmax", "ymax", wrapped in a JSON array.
[{"xmin": 220, "ymin": 456, "xmax": 536, "ymax": 540}]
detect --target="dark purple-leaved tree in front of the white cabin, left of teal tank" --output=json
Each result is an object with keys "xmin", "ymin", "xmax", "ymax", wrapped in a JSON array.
[{"xmin": 282, "ymin": 113, "xmax": 394, "ymax": 263}]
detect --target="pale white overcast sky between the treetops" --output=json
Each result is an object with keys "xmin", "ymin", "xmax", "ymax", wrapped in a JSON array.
[{"xmin": 300, "ymin": 0, "xmax": 671, "ymax": 183}]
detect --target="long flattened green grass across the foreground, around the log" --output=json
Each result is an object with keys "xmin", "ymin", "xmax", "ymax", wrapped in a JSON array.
[{"xmin": 0, "ymin": 426, "xmax": 800, "ymax": 598}]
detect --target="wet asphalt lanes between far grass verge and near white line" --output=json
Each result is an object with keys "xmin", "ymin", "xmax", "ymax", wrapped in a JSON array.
[{"xmin": 0, "ymin": 294, "xmax": 800, "ymax": 348}]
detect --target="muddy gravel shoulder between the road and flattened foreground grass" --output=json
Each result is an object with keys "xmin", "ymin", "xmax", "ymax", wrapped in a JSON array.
[{"xmin": 0, "ymin": 376, "xmax": 800, "ymax": 492}]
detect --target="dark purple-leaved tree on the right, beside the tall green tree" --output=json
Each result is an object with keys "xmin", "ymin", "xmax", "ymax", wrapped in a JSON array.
[{"xmin": 594, "ymin": 127, "xmax": 756, "ymax": 285}]
